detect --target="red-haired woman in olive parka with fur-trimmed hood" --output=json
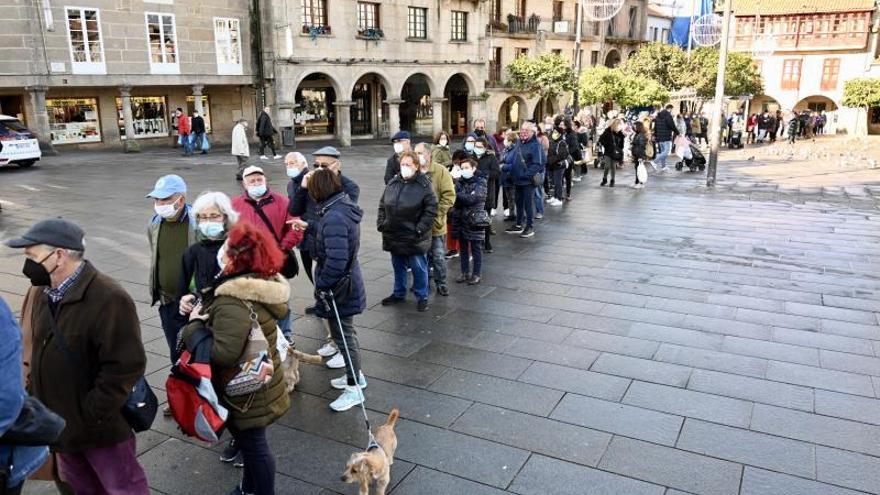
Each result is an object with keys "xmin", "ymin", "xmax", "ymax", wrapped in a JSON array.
[{"xmin": 184, "ymin": 221, "xmax": 290, "ymax": 495}]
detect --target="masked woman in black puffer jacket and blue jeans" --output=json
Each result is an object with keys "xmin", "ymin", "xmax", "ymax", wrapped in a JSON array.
[{"xmin": 376, "ymin": 151, "xmax": 437, "ymax": 311}]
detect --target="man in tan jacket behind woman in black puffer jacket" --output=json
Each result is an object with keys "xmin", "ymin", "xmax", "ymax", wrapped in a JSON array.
[{"xmin": 415, "ymin": 143, "xmax": 455, "ymax": 297}]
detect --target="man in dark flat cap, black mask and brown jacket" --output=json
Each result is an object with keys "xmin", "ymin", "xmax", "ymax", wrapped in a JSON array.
[{"xmin": 6, "ymin": 218, "xmax": 149, "ymax": 495}]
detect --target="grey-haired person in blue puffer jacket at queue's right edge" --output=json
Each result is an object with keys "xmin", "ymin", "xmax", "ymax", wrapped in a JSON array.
[{"xmin": 504, "ymin": 122, "xmax": 546, "ymax": 237}]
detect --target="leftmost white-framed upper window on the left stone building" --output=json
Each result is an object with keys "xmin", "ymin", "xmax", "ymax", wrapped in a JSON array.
[{"xmin": 66, "ymin": 7, "xmax": 107, "ymax": 74}]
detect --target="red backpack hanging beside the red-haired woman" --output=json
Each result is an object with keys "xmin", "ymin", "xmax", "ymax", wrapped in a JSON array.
[{"xmin": 165, "ymin": 328, "xmax": 229, "ymax": 442}]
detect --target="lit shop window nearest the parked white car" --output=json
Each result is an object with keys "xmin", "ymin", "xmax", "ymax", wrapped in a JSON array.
[{"xmin": 46, "ymin": 98, "xmax": 101, "ymax": 144}]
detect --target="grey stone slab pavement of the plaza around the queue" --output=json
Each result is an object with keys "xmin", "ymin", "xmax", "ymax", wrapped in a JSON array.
[{"xmin": 0, "ymin": 140, "xmax": 880, "ymax": 495}]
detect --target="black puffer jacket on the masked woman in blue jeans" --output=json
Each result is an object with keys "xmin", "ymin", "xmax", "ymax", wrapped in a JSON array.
[{"xmin": 376, "ymin": 173, "xmax": 437, "ymax": 256}]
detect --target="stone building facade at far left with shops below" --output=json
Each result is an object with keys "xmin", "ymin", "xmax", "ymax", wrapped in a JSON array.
[{"xmin": 0, "ymin": 0, "xmax": 256, "ymax": 152}]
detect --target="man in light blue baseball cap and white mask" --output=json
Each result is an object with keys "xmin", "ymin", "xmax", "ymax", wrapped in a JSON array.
[{"xmin": 146, "ymin": 174, "xmax": 196, "ymax": 364}]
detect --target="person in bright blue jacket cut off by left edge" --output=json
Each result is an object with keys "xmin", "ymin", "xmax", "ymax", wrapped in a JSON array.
[{"xmin": 0, "ymin": 298, "xmax": 49, "ymax": 495}]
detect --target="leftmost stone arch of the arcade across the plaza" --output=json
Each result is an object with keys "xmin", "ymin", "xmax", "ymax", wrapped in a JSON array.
[{"xmin": 293, "ymin": 70, "xmax": 340, "ymax": 137}]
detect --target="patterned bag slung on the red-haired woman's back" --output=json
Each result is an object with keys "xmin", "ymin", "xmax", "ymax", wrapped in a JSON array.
[{"xmin": 225, "ymin": 301, "xmax": 277, "ymax": 407}]
